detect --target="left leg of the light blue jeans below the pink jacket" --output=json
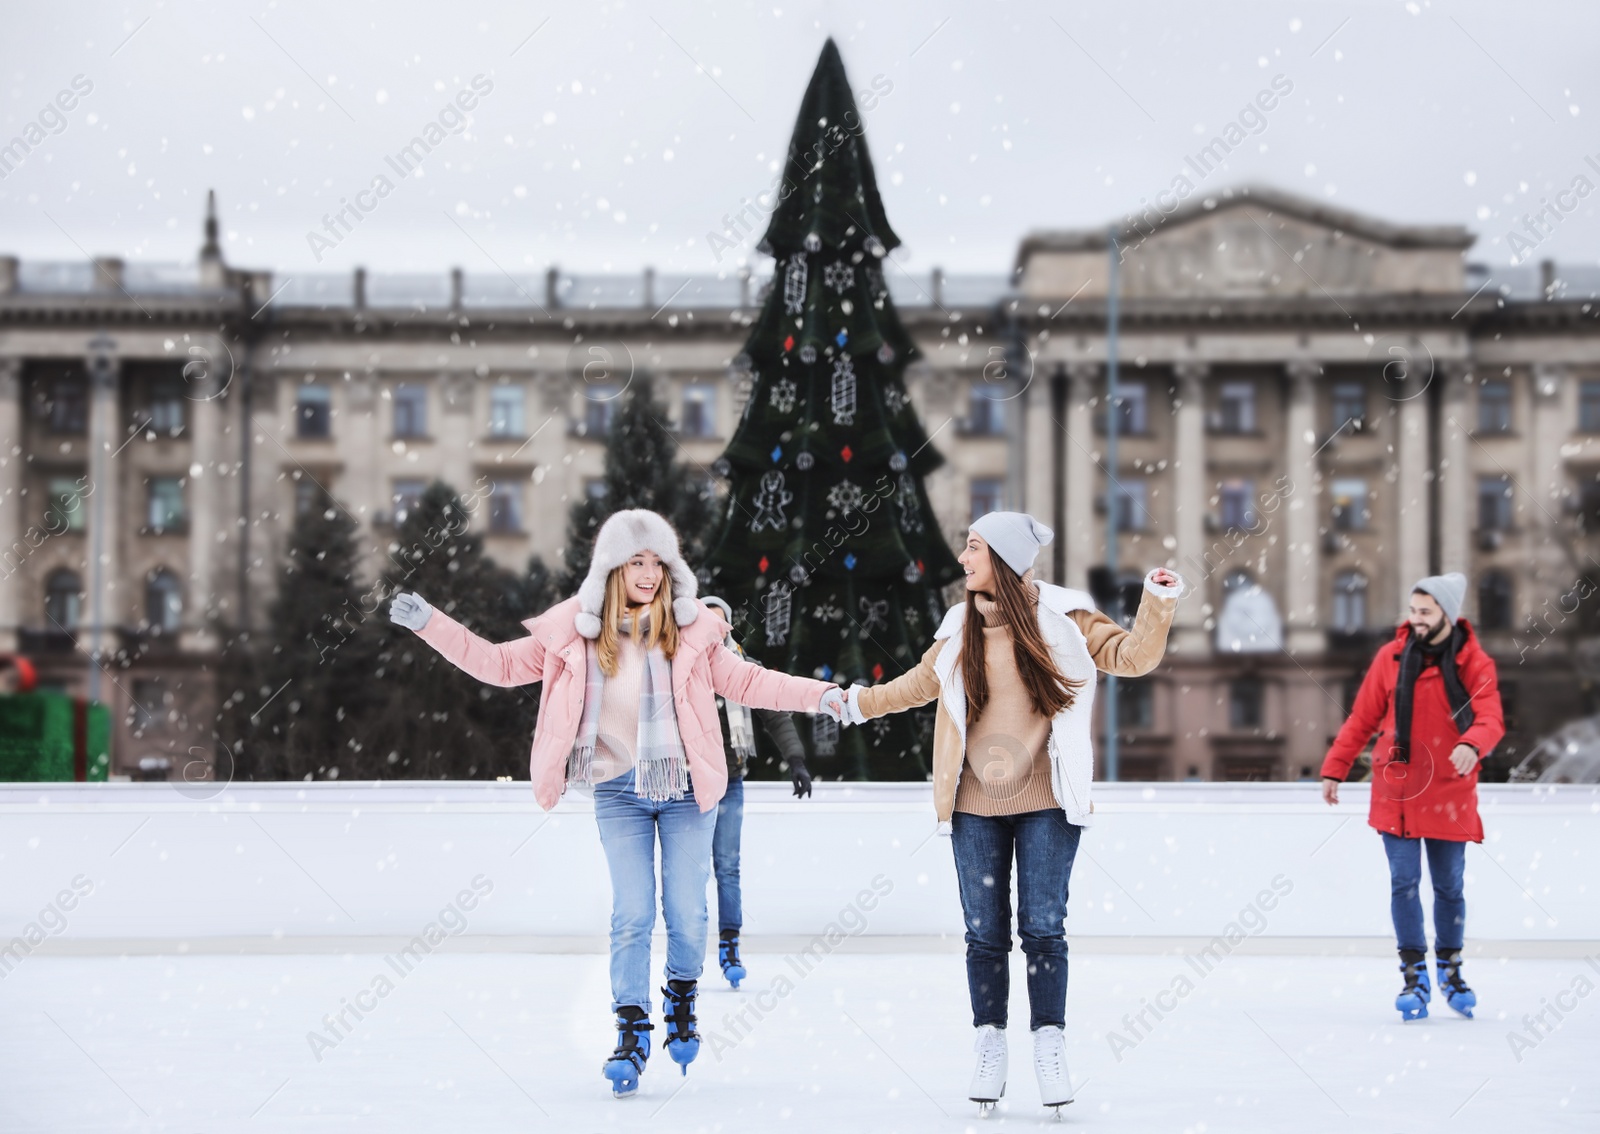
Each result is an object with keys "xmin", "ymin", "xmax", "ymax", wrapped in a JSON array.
[{"xmin": 595, "ymin": 773, "xmax": 656, "ymax": 1012}]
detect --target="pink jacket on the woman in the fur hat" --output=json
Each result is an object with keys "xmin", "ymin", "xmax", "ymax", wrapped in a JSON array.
[{"xmin": 416, "ymin": 598, "xmax": 837, "ymax": 811}]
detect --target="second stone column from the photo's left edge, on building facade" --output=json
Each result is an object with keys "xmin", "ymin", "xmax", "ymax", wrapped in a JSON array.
[{"xmin": 84, "ymin": 334, "xmax": 121, "ymax": 681}]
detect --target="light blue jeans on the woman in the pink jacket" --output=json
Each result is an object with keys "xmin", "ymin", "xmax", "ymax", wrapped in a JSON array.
[{"xmin": 595, "ymin": 771, "xmax": 717, "ymax": 1012}]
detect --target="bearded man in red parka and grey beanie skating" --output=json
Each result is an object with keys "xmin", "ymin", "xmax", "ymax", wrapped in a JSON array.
[{"xmin": 1322, "ymin": 573, "xmax": 1506, "ymax": 1020}]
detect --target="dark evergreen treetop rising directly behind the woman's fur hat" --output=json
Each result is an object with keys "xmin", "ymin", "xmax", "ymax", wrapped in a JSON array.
[{"xmin": 562, "ymin": 374, "xmax": 715, "ymax": 595}]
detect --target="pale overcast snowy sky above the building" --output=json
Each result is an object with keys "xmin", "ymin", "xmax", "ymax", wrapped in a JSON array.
[{"xmin": 0, "ymin": 0, "xmax": 1600, "ymax": 274}]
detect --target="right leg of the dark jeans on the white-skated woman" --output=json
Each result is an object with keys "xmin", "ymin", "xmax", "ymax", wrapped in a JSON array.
[{"xmin": 1013, "ymin": 808, "xmax": 1083, "ymax": 1032}]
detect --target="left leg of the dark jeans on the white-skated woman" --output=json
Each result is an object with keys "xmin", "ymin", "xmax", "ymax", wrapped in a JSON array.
[{"xmin": 950, "ymin": 811, "xmax": 1013, "ymax": 1028}]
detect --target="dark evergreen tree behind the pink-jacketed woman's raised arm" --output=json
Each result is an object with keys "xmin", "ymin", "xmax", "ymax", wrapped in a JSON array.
[{"xmin": 362, "ymin": 481, "xmax": 538, "ymax": 779}]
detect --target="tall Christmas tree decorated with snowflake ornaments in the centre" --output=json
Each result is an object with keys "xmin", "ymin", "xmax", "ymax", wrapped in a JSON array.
[{"xmin": 704, "ymin": 40, "xmax": 960, "ymax": 779}]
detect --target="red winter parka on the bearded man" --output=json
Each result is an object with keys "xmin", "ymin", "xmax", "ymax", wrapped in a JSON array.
[{"xmin": 1322, "ymin": 619, "xmax": 1506, "ymax": 843}]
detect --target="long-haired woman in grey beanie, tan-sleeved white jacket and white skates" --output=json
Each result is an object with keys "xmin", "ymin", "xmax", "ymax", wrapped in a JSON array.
[{"xmin": 845, "ymin": 512, "xmax": 1182, "ymax": 1112}]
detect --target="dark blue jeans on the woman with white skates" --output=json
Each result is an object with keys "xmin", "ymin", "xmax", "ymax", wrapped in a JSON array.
[{"xmin": 950, "ymin": 808, "xmax": 1083, "ymax": 1032}]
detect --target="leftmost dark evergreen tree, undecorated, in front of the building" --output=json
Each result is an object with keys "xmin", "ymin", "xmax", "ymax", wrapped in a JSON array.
[{"xmin": 232, "ymin": 496, "xmax": 381, "ymax": 779}]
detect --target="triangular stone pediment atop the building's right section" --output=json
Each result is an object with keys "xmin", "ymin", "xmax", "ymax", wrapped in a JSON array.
[{"xmin": 1014, "ymin": 187, "xmax": 1474, "ymax": 299}]
